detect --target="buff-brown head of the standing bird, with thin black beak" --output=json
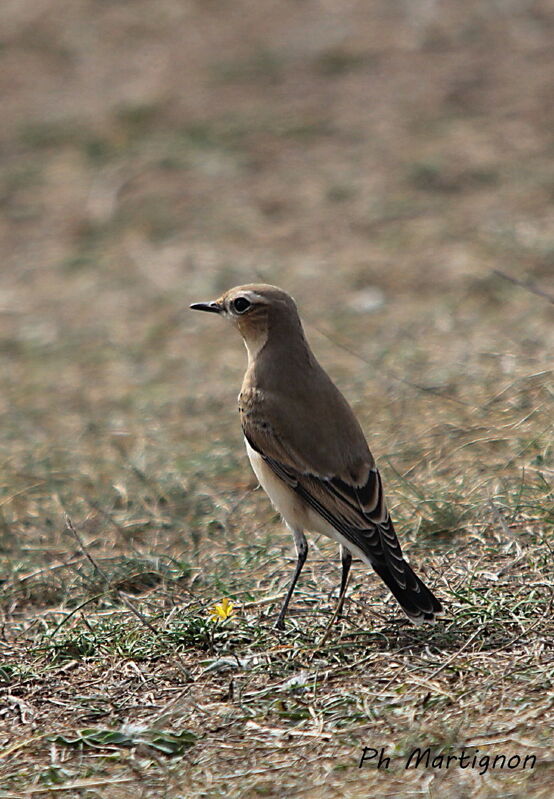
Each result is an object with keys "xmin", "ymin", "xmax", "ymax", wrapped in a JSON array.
[{"xmin": 190, "ymin": 283, "xmax": 301, "ymax": 358}]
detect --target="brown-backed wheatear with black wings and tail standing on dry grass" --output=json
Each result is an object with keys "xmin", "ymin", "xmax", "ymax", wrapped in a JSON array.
[{"xmin": 190, "ymin": 284, "xmax": 442, "ymax": 629}]
